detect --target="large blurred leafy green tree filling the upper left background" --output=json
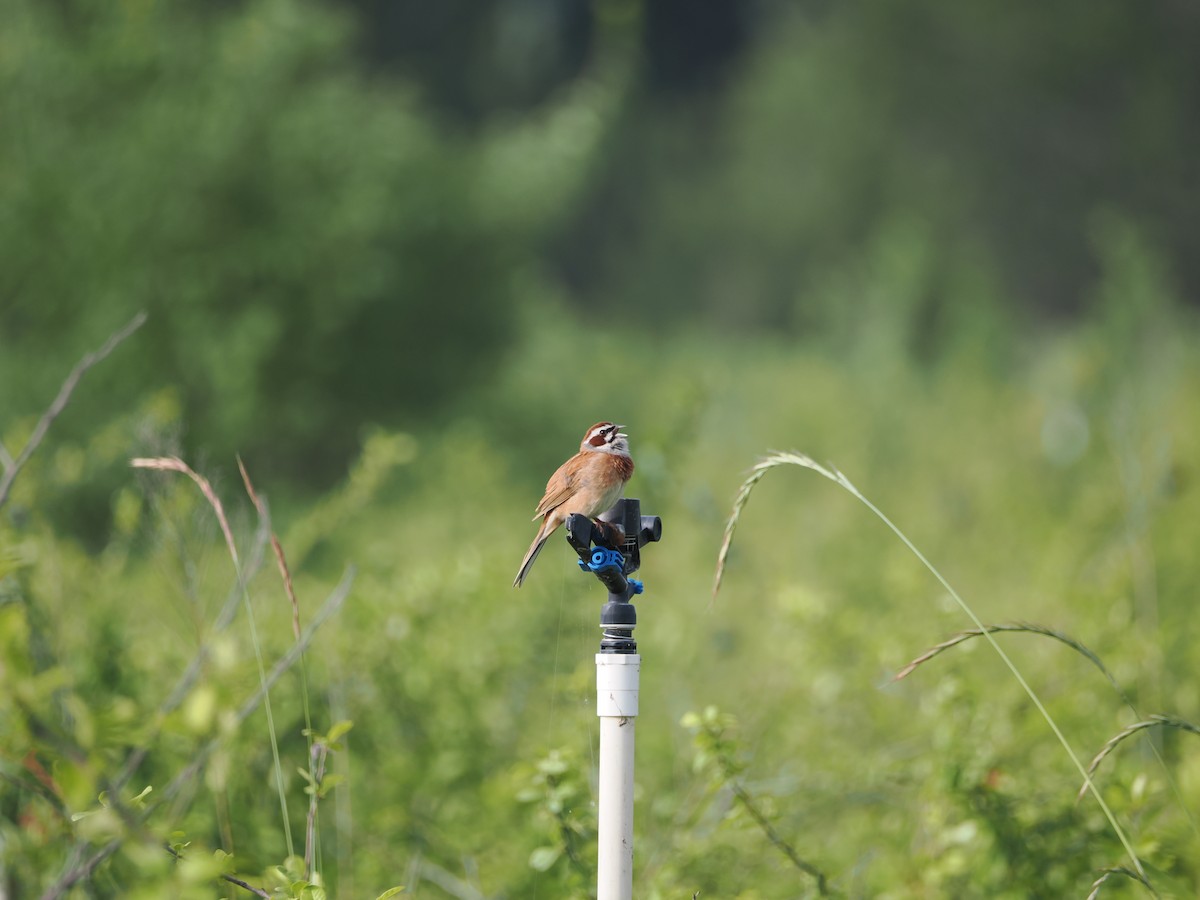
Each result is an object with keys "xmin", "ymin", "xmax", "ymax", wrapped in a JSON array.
[{"xmin": 0, "ymin": 0, "xmax": 614, "ymax": 485}]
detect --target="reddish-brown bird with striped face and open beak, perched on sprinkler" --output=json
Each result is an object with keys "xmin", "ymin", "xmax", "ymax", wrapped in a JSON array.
[{"xmin": 512, "ymin": 422, "xmax": 634, "ymax": 588}]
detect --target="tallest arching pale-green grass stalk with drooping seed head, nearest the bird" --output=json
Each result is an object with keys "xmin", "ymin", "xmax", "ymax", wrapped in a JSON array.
[{"xmin": 713, "ymin": 451, "xmax": 1153, "ymax": 890}]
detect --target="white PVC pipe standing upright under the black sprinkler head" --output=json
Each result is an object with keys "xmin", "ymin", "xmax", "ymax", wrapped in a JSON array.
[{"xmin": 596, "ymin": 653, "xmax": 642, "ymax": 900}]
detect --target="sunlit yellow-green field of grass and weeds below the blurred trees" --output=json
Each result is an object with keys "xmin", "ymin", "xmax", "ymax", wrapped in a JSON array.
[{"xmin": 0, "ymin": 300, "xmax": 1200, "ymax": 900}]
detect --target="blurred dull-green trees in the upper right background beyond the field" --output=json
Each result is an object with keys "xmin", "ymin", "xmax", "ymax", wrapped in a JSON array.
[{"xmin": 556, "ymin": 0, "xmax": 1200, "ymax": 342}]
